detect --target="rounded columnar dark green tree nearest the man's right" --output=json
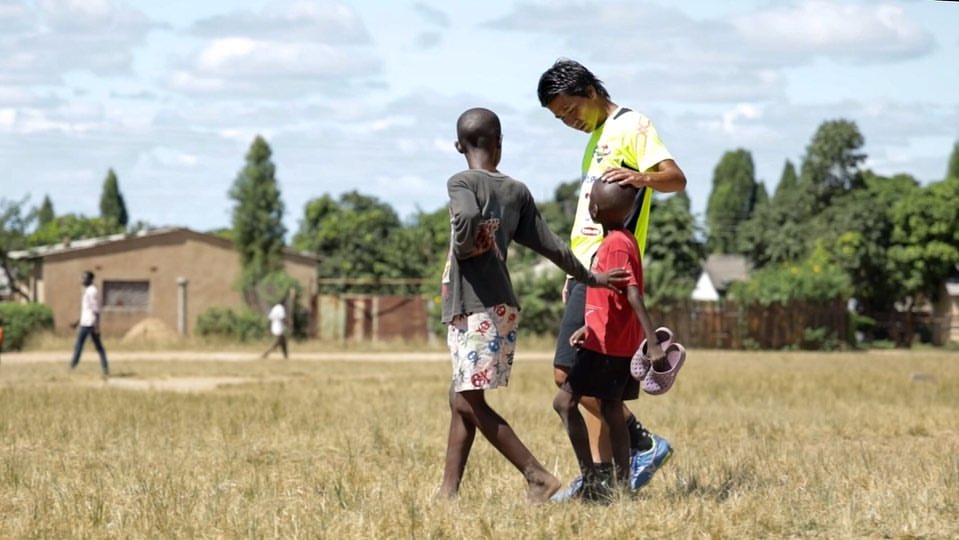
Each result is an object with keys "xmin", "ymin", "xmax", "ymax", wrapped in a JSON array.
[{"xmin": 706, "ymin": 148, "xmax": 757, "ymax": 253}]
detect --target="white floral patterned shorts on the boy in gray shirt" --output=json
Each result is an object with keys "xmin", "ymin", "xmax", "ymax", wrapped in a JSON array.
[{"xmin": 446, "ymin": 304, "xmax": 519, "ymax": 392}]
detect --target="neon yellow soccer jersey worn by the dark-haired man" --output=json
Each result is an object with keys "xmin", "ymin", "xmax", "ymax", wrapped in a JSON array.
[{"xmin": 570, "ymin": 107, "xmax": 672, "ymax": 268}]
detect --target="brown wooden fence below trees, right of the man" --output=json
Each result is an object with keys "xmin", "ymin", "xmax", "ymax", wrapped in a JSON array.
[{"xmin": 650, "ymin": 301, "xmax": 849, "ymax": 349}]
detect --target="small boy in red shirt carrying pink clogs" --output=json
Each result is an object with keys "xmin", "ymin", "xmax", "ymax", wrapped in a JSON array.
[{"xmin": 553, "ymin": 181, "xmax": 664, "ymax": 501}]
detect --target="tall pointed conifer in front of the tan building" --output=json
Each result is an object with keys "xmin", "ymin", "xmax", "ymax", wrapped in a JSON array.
[{"xmin": 229, "ymin": 135, "xmax": 286, "ymax": 307}]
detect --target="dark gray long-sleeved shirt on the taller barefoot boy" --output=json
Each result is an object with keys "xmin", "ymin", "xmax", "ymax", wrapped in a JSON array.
[{"xmin": 443, "ymin": 169, "xmax": 590, "ymax": 323}]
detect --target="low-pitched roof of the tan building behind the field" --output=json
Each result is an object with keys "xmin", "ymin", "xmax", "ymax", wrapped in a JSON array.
[{"xmin": 9, "ymin": 227, "xmax": 319, "ymax": 263}]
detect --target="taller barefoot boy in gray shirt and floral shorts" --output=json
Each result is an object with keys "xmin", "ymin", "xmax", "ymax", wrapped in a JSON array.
[{"xmin": 437, "ymin": 108, "xmax": 627, "ymax": 503}]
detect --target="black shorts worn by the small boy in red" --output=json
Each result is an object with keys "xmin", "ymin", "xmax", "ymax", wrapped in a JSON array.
[{"xmin": 562, "ymin": 349, "xmax": 639, "ymax": 401}]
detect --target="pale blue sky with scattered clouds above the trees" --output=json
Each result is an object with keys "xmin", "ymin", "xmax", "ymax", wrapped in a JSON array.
[{"xmin": 0, "ymin": 0, "xmax": 959, "ymax": 234}]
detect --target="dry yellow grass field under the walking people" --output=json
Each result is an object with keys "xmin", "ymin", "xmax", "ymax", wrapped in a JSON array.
[{"xmin": 0, "ymin": 343, "xmax": 959, "ymax": 539}]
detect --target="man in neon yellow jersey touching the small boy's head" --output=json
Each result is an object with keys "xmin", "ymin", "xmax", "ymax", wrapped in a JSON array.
[{"xmin": 537, "ymin": 59, "xmax": 686, "ymax": 498}]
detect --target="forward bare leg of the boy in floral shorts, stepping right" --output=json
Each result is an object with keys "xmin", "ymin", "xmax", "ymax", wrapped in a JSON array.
[{"xmin": 454, "ymin": 390, "xmax": 560, "ymax": 503}]
